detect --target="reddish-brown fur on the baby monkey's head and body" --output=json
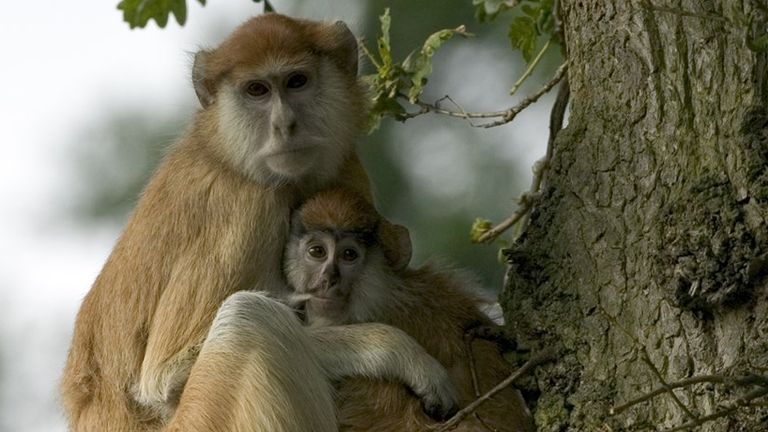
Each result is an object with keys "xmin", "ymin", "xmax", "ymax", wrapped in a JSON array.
[{"xmin": 287, "ymin": 188, "xmax": 534, "ymax": 432}]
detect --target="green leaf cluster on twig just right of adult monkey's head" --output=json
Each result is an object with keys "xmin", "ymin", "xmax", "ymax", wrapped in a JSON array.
[{"xmin": 363, "ymin": 9, "xmax": 471, "ymax": 129}]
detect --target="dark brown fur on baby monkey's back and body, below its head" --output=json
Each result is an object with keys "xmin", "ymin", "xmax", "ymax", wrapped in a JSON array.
[{"xmin": 337, "ymin": 266, "xmax": 534, "ymax": 432}]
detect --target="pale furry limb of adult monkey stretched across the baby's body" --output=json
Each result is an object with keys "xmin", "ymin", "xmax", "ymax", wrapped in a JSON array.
[{"xmin": 309, "ymin": 323, "xmax": 459, "ymax": 419}]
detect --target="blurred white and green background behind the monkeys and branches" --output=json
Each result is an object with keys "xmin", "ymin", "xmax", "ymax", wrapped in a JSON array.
[{"xmin": 0, "ymin": 0, "xmax": 556, "ymax": 431}]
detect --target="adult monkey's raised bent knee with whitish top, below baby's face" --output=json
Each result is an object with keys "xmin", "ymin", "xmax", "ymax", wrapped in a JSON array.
[{"xmin": 167, "ymin": 292, "xmax": 338, "ymax": 432}]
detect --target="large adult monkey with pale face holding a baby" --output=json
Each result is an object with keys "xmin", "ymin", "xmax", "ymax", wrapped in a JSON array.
[{"xmin": 61, "ymin": 14, "xmax": 455, "ymax": 431}]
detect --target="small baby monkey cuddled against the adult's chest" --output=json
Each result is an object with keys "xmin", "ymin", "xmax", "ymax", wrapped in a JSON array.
[{"xmin": 285, "ymin": 188, "xmax": 534, "ymax": 432}]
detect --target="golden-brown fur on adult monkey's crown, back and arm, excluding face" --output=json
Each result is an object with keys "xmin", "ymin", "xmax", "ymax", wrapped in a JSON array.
[{"xmin": 61, "ymin": 15, "xmax": 369, "ymax": 431}]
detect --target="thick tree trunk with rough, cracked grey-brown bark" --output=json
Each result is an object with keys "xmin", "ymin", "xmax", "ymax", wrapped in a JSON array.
[{"xmin": 503, "ymin": 0, "xmax": 768, "ymax": 431}]
